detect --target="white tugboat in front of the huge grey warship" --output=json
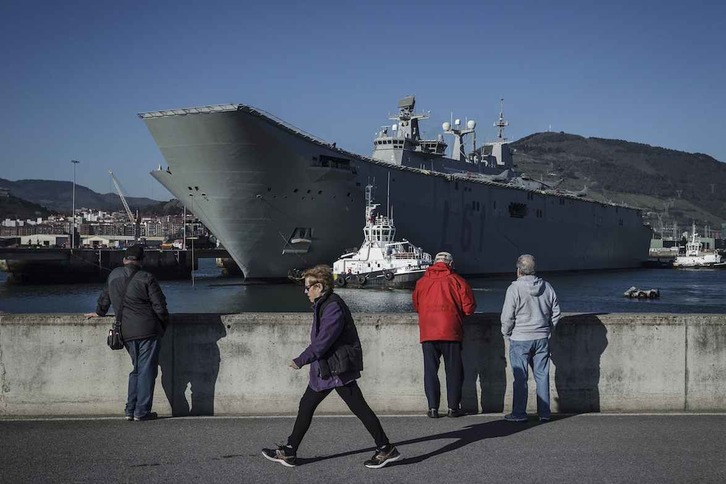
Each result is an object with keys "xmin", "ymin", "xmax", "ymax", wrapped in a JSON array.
[{"xmin": 333, "ymin": 185, "xmax": 432, "ymax": 287}]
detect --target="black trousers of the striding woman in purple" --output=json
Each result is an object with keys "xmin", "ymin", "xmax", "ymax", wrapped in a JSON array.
[{"xmin": 287, "ymin": 380, "xmax": 388, "ymax": 451}]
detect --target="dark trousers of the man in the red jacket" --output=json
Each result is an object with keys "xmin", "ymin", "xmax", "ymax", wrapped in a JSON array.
[{"xmin": 421, "ymin": 341, "xmax": 464, "ymax": 409}]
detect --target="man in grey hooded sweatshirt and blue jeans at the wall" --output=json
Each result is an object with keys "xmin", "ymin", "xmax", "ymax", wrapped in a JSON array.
[{"xmin": 501, "ymin": 254, "xmax": 560, "ymax": 422}]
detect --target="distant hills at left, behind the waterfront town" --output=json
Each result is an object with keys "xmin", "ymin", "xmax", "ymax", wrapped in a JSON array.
[{"xmin": 0, "ymin": 178, "xmax": 159, "ymax": 213}]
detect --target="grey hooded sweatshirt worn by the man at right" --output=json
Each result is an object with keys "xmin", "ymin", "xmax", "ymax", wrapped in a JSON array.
[{"xmin": 502, "ymin": 276, "xmax": 560, "ymax": 341}]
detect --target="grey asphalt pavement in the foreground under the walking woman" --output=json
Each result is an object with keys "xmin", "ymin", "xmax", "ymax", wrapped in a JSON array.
[{"xmin": 0, "ymin": 415, "xmax": 726, "ymax": 484}]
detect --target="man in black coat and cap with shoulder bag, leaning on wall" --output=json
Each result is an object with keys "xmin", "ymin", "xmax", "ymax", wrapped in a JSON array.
[{"xmin": 86, "ymin": 245, "xmax": 169, "ymax": 421}]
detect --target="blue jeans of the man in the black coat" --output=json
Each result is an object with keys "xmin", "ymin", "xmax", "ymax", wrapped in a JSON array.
[{"xmin": 124, "ymin": 337, "xmax": 161, "ymax": 417}]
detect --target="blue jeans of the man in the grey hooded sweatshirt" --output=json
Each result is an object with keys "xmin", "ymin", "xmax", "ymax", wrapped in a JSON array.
[{"xmin": 509, "ymin": 338, "xmax": 550, "ymax": 418}]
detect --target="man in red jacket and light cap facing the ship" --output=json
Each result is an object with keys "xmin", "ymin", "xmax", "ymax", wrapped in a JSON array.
[{"xmin": 413, "ymin": 252, "xmax": 476, "ymax": 418}]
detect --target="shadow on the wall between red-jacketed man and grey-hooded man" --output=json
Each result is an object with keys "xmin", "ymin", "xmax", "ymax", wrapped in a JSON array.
[{"xmin": 461, "ymin": 314, "xmax": 507, "ymax": 413}]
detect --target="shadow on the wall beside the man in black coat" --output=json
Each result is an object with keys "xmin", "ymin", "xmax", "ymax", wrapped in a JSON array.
[{"xmin": 159, "ymin": 314, "xmax": 227, "ymax": 417}]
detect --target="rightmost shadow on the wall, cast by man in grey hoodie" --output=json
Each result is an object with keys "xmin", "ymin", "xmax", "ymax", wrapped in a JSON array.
[{"xmin": 550, "ymin": 314, "xmax": 608, "ymax": 413}]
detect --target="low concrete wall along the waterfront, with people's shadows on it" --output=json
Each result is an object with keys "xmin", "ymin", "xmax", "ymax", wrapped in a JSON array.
[{"xmin": 0, "ymin": 313, "xmax": 726, "ymax": 416}]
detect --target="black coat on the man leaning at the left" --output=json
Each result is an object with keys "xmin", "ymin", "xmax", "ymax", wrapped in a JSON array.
[{"xmin": 96, "ymin": 264, "xmax": 169, "ymax": 341}]
